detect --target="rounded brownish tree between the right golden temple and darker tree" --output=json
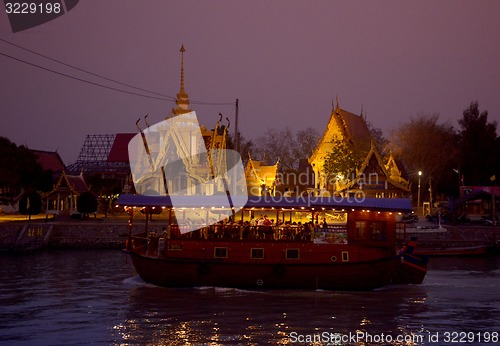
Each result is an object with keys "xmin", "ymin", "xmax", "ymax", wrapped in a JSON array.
[{"xmin": 388, "ymin": 114, "xmax": 459, "ymax": 194}]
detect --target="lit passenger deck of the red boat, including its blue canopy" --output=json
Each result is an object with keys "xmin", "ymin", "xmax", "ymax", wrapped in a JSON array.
[{"xmin": 118, "ymin": 195, "xmax": 411, "ymax": 246}]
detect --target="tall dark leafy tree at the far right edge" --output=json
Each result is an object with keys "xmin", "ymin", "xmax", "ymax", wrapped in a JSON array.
[{"xmin": 458, "ymin": 101, "xmax": 500, "ymax": 185}]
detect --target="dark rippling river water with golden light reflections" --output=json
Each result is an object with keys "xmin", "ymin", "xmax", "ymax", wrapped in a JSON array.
[{"xmin": 0, "ymin": 250, "xmax": 500, "ymax": 345}]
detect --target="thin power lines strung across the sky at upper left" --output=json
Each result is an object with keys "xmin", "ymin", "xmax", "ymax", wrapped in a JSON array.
[{"xmin": 0, "ymin": 38, "xmax": 234, "ymax": 106}]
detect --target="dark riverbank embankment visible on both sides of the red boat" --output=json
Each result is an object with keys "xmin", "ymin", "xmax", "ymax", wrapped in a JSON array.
[{"xmin": 0, "ymin": 214, "xmax": 500, "ymax": 251}]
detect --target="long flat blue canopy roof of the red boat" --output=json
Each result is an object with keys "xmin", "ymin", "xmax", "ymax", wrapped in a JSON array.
[{"xmin": 116, "ymin": 194, "xmax": 412, "ymax": 212}]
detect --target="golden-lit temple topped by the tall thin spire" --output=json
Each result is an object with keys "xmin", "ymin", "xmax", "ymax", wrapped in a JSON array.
[{"xmin": 129, "ymin": 46, "xmax": 229, "ymax": 195}]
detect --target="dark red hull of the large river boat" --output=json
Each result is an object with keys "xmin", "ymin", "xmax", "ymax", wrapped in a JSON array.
[{"xmin": 130, "ymin": 241, "xmax": 400, "ymax": 290}]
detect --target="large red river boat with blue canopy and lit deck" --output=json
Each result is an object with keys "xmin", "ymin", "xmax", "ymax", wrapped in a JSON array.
[{"xmin": 117, "ymin": 194, "xmax": 426, "ymax": 290}]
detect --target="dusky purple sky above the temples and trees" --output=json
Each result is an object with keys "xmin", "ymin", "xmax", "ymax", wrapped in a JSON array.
[{"xmin": 0, "ymin": 0, "xmax": 500, "ymax": 164}]
